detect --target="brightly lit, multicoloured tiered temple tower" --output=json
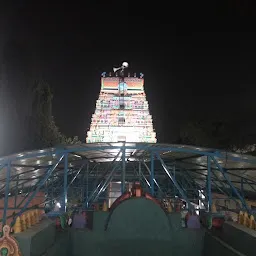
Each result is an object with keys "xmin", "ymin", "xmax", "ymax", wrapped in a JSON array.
[{"xmin": 86, "ymin": 64, "xmax": 156, "ymax": 143}]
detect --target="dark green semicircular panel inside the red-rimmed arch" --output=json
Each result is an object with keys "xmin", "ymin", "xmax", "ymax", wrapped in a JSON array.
[{"xmin": 107, "ymin": 198, "xmax": 171, "ymax": 240}]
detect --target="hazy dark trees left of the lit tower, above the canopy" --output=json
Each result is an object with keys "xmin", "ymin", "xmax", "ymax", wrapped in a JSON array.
[{"xmin": 0, "ymin": 40, "xmax": 79, "ymax": 155}]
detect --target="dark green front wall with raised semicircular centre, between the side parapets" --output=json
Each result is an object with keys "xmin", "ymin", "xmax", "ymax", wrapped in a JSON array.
[{"xmin": 70, "ymin": 198, "xmax": 204, "ymax": 256}]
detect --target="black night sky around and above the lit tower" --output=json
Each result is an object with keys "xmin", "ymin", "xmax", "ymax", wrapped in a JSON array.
[{"xmin": 1, "ymin": 0, "xmax": 256, "ymax": 150}]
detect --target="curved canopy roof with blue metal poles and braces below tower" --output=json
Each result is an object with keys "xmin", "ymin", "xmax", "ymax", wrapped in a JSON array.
[{"xmin": 0, "ymin": 143, "xmax": 256, "ymax": 223}]
